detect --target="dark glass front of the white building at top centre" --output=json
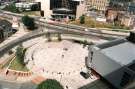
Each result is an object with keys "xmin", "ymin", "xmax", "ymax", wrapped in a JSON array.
[{"xmin": 50, "ymin": 0, "xmax": 79, "ymax": 18}]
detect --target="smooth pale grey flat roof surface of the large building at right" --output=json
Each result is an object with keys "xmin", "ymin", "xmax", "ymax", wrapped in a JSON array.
[{"xmin": 101, "ymin": 41, "xmax": 135, "ymax": 66}]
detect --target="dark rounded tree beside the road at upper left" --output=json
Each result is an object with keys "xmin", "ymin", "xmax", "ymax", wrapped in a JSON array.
[{"xmin": 22, "ymin": 15, "xmax": 35, "ymax": 30}]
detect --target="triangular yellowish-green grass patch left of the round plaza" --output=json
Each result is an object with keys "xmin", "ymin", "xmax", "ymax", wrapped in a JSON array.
[{"xmin": 9, "ymin": 57, "xmax": 29, "ymax": 72}]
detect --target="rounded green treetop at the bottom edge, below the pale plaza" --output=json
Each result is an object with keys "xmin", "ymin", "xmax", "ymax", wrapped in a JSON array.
[{"xmin": 37, "ymin": 79, "xmax": 64, "ymax": 89}]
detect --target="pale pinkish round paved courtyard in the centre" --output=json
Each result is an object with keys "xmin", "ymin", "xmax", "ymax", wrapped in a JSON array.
[{"xmin": 25, "ymin": 40, "xmax": 88, "ymax": 76}]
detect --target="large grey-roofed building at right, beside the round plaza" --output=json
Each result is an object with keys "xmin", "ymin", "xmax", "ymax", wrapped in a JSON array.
[{"xmin": 87, "ymin": 32, "xmax": 135, "ymax": 89}]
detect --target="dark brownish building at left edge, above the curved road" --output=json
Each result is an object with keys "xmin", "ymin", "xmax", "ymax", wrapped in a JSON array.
[{"xmin": 0, "ymin": 20, "xmax": 13, "ymax": 42}]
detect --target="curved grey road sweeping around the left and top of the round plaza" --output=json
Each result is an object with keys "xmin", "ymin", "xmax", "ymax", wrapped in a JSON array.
[{"xmin": 0, "ymin": 28, "xmax": 115, "ymax": 57}]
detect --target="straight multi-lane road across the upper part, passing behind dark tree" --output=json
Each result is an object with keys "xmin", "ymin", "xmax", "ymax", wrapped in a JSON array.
[{"xmin": 0, "ymin": 10, "xmax": 128, "ymax": 37}]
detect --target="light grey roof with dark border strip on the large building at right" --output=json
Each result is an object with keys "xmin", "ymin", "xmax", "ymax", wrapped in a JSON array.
[{"xmin": 96, "ymin": 31, "xmax": 135, "ymax": 68}]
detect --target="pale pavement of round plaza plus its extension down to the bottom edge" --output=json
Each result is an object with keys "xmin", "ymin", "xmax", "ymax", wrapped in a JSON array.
[{"xmin": 24, "ymin": 38, "xmax": 112, "ymax": 89}]
